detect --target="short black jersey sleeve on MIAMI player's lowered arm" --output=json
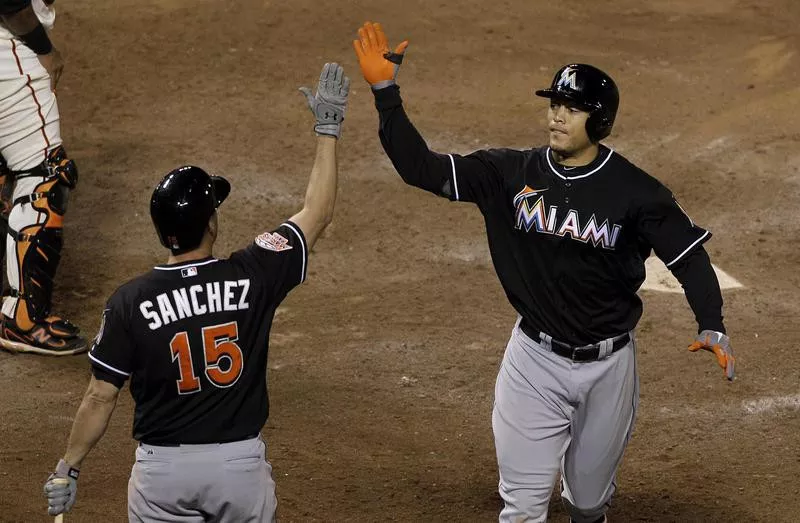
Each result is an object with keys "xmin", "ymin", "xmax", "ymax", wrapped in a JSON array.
[{"xmin": 638, "ymin": 184, "xmax": 711, "ymax": 268}]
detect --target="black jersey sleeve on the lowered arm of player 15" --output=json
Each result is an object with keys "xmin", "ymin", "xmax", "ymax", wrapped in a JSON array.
[{"xmin": 89, "ymin": 294, "xmax": 134, "ymax": 385}]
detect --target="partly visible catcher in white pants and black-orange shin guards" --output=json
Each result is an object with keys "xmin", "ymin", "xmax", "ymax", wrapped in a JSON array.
[{"xmin": 0, "ymin": 0, "xmax": 87, "ymax": 356}]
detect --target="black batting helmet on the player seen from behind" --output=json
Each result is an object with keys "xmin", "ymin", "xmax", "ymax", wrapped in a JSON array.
[{"xmin": 150, "ymin": 165, "xmax": 231, "ymax": 254}]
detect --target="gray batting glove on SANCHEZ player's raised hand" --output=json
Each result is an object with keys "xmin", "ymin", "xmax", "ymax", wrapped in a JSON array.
[{"xmin": 300, "ymin": 63, "xmax": 350, "ymax": 138}]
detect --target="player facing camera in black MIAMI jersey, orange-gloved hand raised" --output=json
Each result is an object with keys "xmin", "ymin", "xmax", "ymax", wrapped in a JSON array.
[{"xmin": 353, "ymin": 22, "xmax": 734, "ymax": 523}]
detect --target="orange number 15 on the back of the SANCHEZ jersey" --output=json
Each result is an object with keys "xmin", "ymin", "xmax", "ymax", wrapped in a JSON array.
[{"xmin": 169, "ymin": 321, "xmax": 244, "ymax": 394}]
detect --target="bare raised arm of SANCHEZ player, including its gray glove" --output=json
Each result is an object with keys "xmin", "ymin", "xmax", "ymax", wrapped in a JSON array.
[{"xmin": 291, "ymin": 63, "xmax": 350, "ymax": 250}]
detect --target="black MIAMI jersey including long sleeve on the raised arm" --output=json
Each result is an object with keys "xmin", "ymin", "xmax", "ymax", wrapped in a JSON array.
[{"xmin": 375, "ymin": 86, "xmax": 721, "ymax": 345}]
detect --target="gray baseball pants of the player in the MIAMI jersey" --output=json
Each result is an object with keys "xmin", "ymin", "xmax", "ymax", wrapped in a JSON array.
[{"xmin": 492, "ymin": 320, "xmax": 639, "ymax": 523}]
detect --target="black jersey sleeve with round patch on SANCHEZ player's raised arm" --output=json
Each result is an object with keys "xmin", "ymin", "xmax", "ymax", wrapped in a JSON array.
[{"xmin": 231, "ymin": 221, "xmax": 308, "ymax": 300}]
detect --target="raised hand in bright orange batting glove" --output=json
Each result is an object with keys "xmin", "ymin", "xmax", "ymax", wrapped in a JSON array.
[{"xmin": 353, "ymin": 22, "xmax": 408, "ymax": 91}]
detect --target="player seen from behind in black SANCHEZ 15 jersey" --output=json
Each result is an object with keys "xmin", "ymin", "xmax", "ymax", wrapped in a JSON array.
[{"xmin": 39, "ymin": 64, "xmax": 350, "ymax": 523}]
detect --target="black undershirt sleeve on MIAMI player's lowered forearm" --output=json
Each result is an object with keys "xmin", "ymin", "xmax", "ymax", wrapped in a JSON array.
[{"xmin": 670, "ymin": 246, "xmax": 725, "ymax": 333}]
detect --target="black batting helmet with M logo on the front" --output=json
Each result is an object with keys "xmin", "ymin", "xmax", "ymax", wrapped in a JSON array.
[{"xmin": 536, "ymin": 64, "xmax": 619, "ymax": 142}]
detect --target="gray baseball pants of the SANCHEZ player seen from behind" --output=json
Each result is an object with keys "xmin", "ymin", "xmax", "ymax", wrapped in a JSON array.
[{"xmin": 128, "ymin": 436, "xmax": 277, "ymax": 523}]
